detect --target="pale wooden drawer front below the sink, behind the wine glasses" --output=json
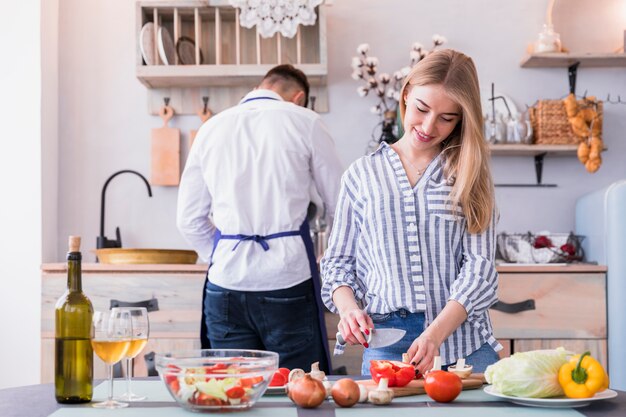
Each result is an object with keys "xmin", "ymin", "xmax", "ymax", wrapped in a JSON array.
[{"xmin": 41, "ymin": 273, "xmax": 205, "ymax": 338}]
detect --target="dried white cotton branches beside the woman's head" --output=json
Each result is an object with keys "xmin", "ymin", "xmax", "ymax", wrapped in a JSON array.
[{"xmin": 351, "ymin": 35, "xmax": 447, "ymax": 115}]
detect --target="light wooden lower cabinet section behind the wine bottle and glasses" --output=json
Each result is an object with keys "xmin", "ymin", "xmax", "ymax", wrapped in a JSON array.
[{"xmin": 41, "ymin": 264, "xmax": 206, "ymax": 383}]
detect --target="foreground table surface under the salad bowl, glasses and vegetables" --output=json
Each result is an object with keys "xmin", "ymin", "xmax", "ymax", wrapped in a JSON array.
[{"xmin": 0, "ymin": 377, "xmax": 626, "ymax": 417}]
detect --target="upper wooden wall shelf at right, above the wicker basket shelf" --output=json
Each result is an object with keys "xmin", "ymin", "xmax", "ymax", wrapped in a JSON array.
[{"xmin": 520, "ymin": 52, "xmax": 626, "ymax": 68}]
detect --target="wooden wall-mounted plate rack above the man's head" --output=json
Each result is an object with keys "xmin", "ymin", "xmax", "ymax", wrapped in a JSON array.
[{"xmin": 136, "ymin": 0, "xmax": 328, "ymax": 114}]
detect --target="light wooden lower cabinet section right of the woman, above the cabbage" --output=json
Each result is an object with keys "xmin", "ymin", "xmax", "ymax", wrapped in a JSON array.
[{"xmin": 490, "ymin": 265, "xmax": 607, "ymax": 367}]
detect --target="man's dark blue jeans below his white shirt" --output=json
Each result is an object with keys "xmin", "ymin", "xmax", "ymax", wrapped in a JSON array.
[{"xmin": 204, "ymin": 280, "xmax": 329, "ymax": 372}]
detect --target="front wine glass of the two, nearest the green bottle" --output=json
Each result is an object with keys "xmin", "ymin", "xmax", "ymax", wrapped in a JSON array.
[{"xmin": 91, "ymin": 309, "xmax": 133, "ymax": 409}]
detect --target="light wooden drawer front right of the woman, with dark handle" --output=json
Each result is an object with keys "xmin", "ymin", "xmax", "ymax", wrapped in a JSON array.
[{"xmin": 489, "ymin": 273, "xmax": 606, "ymax": 338}]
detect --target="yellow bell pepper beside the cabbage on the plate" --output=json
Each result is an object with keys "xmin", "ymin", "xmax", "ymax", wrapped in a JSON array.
[{"xmin": 559, "ymin": 352, "xmax": 609, "ymax": 398}]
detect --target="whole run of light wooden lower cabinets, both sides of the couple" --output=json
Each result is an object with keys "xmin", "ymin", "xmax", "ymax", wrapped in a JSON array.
[{"xmin": 41, "ymin": 264, "xmax": 607, "ymax": 383}]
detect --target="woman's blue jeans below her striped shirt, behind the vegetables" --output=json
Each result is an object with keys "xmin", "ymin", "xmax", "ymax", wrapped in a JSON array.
[{"xmin": 361, "ymin": 309, "xmax": 498, "ymax": 375}]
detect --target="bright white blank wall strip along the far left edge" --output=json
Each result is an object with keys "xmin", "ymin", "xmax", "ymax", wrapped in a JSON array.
[{"xmin": 0, "ymin": 0, "xmax": 42, "ymax": 388}]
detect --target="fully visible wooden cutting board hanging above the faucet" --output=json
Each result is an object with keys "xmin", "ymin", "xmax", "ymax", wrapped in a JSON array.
[{"xmin": 150, "ymin": 105, "xmax": 180, "ymax": 186}]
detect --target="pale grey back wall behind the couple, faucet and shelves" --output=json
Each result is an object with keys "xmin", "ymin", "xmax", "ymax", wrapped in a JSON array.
[{"xmin": 53, "ymin": 0, "xmax": 626, "ymax": 261}]
